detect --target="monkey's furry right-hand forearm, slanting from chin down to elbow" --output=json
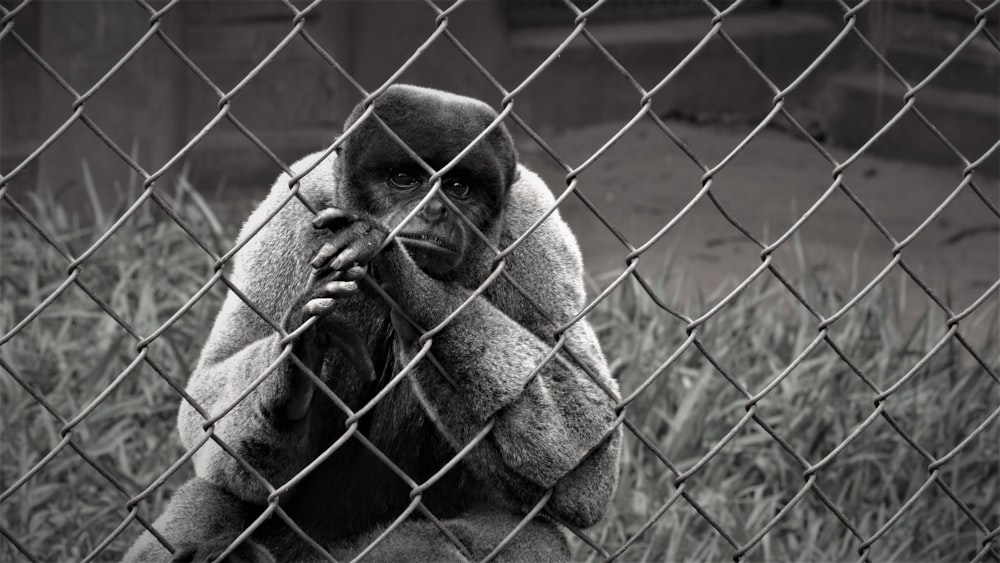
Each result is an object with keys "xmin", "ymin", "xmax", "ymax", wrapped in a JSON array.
[{"xmin": 386, "ymin": 262, "xmax": 620, "ymax": 527}]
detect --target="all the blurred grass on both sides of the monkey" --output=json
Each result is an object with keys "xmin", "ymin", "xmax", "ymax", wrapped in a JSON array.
[{"xmin": 0, "ymin": 177, "xmax": 1000, "ymax": 561}]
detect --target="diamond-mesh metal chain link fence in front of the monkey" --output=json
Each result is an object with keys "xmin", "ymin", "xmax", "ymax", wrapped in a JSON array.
[{"xmin": 0, "ymin": 0, "xmax": 1000, "ymax": 561}]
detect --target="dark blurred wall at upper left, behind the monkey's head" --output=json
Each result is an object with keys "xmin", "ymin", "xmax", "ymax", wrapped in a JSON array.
[{"xmin": 0, "ymin": 0, "xmax": 506, "ymax": 207}]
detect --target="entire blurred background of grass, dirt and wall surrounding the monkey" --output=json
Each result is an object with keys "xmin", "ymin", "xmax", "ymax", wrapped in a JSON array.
[{"xmin": 0, "ymin": 0, "xmax": 1000, "ymax": 561}]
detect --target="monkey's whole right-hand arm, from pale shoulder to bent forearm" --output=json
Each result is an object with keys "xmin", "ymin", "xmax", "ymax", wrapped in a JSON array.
[{"xmin": 380, "ymin": 170, "xmax": 620, "ymax": 527}]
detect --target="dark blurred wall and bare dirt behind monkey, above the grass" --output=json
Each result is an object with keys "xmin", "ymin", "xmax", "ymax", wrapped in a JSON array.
[{"xmin": 0, "ymin": 0, "xmax": 1000, "ymax": 302}]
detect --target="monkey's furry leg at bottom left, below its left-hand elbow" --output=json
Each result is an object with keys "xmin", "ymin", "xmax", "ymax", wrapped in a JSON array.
[{"xmin": 123, "ymin": 477, "xmax": 274, "ymax": 563}]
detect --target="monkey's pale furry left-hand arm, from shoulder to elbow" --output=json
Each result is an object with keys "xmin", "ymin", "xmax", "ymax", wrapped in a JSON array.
[{"xmin": 178, "ymin": 151, "xmax": 340, "ymax": 502}]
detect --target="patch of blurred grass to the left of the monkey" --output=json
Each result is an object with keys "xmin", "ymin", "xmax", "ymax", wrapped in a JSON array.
[{"xmin": 0, "ymin": 174, "xmax": 232, "ymax": 561}]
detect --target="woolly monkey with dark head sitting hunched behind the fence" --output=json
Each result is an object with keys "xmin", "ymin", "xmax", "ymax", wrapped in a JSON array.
[{"xmin": 125, "ymin": 84, "xmax": 621, "ymax": 563}]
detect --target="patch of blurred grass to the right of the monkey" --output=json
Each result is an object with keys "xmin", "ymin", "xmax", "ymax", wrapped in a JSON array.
[{"xmin": 575, "ymin": 253, "xmax": 1000, "ymax": 561}]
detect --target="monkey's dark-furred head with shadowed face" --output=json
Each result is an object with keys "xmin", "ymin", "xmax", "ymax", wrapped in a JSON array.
[{"xmin": 335, "ymin": 85, "xmax": 517, "ymax": 279}]
